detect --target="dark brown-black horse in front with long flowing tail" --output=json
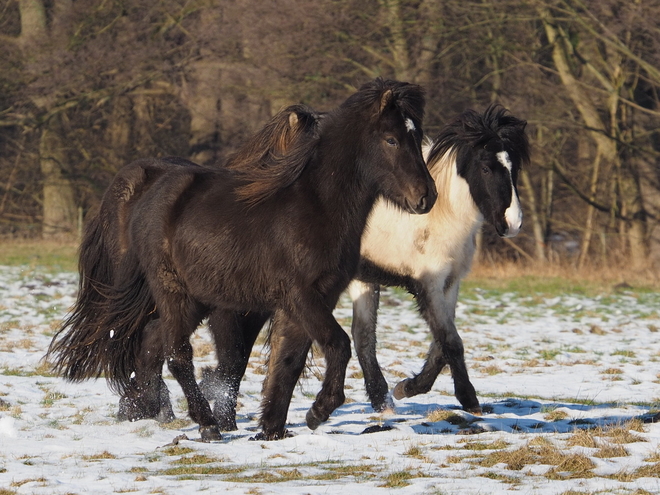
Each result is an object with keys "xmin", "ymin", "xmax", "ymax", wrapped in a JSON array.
[{"xmin": 46, "ymin": 79, "xmax": 437, "ymax": 440}]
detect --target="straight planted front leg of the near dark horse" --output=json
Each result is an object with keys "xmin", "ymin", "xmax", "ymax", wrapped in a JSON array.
[{"xmin": 255, "ymin": 311, "xmax": 312, "ymax": 440}]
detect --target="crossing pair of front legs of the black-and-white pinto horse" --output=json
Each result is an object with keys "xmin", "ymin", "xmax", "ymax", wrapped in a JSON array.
[{"xmin": 394, "ymin": 283, "xmax": 481, "ymax": 414}]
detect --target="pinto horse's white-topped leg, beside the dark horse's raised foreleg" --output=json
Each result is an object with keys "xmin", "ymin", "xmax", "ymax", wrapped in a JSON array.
[{"xmin": 349, "ymin": 280, "xmax": 394, "ymax": 412}]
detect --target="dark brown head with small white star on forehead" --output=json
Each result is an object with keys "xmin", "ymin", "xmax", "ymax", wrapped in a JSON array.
[{"xmin": 346, "ymin": 78, "xmax": 437, "ymax": 213}]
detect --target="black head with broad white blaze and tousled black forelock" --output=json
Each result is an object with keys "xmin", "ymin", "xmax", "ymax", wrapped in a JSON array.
[{"xmin": 429, "ymin": 105, "xmax": 529, "ymax": 237}]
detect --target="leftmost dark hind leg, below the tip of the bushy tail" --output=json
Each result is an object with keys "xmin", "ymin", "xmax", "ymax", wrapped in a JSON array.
[{"xmin": 117, "ymin": 320, "xmax": 174, "ymax": 423}]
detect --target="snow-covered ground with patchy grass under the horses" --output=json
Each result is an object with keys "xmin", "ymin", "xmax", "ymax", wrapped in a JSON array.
[{"xmin": 0, "ymin": 267, "xmax": 660, "ymax": 495}]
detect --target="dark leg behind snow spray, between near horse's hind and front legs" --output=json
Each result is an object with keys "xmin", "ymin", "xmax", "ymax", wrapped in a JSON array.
[{"xmin": 199, "ymin": 310, "xmax": 269, "ymax": 431}]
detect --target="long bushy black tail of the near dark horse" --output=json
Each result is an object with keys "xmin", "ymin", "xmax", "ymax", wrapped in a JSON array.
[{"xmin": 45, "ymin": 162, "xmax": 158, "ymax": 393}]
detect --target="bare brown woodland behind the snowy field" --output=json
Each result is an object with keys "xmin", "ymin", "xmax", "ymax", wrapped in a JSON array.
[{"xmin": 0, "ymin": 0, "xmax": 660, "ymax": 276}]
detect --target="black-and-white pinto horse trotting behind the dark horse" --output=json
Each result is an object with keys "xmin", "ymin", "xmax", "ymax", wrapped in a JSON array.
[{"xmin": 349, "ymin": 105, "xmax": 530, "ymax": 413}]
